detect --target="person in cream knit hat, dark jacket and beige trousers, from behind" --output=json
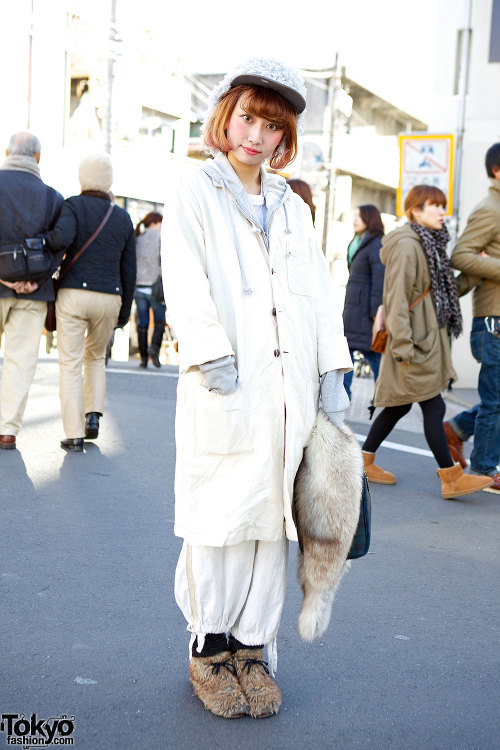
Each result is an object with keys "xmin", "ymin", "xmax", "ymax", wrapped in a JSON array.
[{"xmin": 46, "ymin": 154, "xmax": 136, "ymax": 451}]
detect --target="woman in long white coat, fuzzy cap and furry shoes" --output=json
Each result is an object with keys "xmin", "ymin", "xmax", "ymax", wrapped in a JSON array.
[{"xmin": 162, "ymin": 60, "xmax": 351, "ymax": 718}]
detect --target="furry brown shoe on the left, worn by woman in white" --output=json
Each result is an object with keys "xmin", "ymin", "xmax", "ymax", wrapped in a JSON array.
[{"xmin": 189, "ymin": 651, "xmax": 250, "ymax": 719}]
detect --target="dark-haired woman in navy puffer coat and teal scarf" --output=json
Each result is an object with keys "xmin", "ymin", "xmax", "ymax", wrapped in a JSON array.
[{"xmin": 344, "ymin": 204, "xmax": 385, "ymax": 398}]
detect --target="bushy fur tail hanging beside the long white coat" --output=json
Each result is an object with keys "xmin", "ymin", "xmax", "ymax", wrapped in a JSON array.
[{"xmin": 293, "ymin": 410, "xmax": 363, "ymax": 641}]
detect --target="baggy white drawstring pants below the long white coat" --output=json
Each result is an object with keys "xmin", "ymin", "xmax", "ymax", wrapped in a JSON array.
[{"xmin": 175, "ymin": 537, "xmax": 288, "ymax": 673}]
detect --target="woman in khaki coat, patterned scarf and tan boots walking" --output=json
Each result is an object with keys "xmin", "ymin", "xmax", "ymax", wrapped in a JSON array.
[{"xmin": 363, "ymin": 185, "xmax": 492, "ymax": 498}]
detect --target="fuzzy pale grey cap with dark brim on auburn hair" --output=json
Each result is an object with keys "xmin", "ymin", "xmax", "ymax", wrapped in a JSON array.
[{"xmin": 204, "ymin": 58, "xmax": 306, "ymax": 135}]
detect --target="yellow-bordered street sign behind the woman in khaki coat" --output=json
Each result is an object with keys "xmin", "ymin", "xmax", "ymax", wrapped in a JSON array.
[{"xmin": 396, "ymin": 133, "xmax": 453, "ymax": 216}]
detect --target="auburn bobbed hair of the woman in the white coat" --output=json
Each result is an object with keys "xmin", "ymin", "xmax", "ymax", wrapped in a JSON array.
[{"xmin": 203, "ymin": 85, "xmax": 297, "ymax": 169}]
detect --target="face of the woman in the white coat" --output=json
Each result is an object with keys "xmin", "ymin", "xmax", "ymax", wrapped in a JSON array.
[{"xmin": 227, "ymin": 93, "xmax": 283, "ymax": 166}]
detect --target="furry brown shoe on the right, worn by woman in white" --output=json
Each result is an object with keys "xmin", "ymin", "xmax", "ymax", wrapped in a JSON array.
[{"xmin": 233, "ymin": 648, "xmax": 281, "ymax": 719}]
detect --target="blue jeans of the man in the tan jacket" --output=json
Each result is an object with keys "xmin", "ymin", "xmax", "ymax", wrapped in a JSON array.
[{"xmin": 450, "ymin": 317, "xmax": 500, "ymax": 476}]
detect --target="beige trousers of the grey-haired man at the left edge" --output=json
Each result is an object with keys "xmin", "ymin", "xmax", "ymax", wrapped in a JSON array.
[{"xmin": 0, "ymin": 297, "xmax": 47, "ymax": 435}]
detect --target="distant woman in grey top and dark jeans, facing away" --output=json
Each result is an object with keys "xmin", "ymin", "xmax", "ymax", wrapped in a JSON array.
[{"xmin": 134, "ymin": 211, "xmax": 167, "ymax": 367}]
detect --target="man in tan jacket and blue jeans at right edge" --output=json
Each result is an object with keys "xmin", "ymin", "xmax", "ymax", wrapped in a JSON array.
[{"xmin": 445, "ymin": 143, "xmax": 500, "ymax": 493}]
